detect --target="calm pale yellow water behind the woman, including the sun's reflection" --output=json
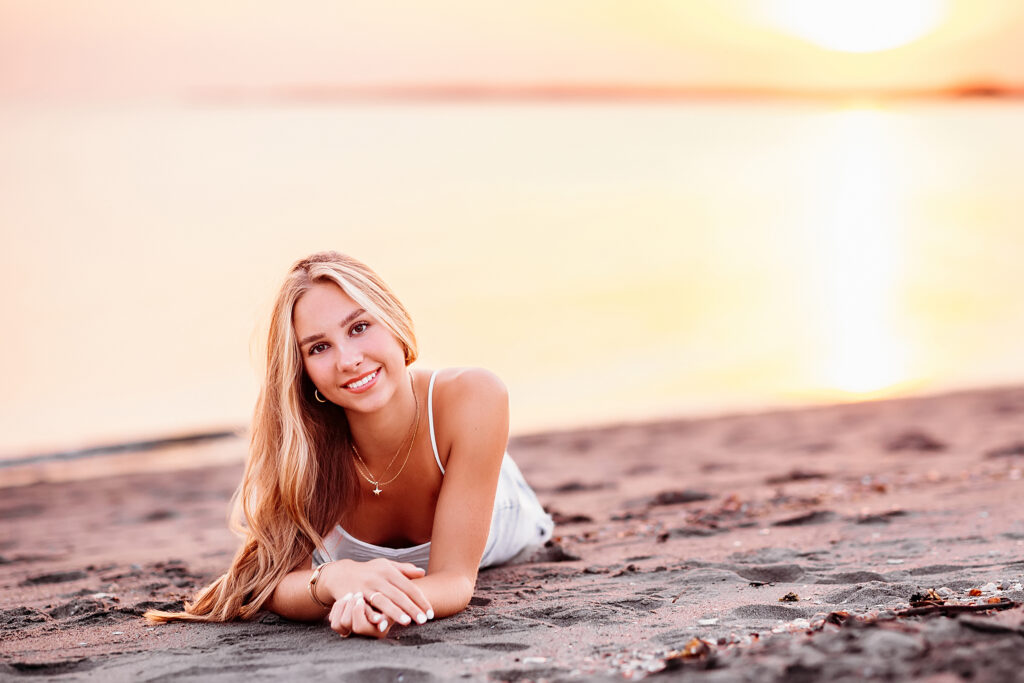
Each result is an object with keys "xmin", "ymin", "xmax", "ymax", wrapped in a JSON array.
[{"xmin": 0, "ymin": 101, "xmax": 1024, "ymax": 457}]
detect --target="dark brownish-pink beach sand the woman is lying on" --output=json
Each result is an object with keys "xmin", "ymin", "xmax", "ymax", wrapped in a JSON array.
[{"xmin": 0, "ymin": 388, "xmax": 1024, "ymax": 683}]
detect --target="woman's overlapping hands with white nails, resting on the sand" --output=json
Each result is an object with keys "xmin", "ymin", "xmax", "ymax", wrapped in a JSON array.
[{"xmin": 317, "ymin": 558, "xmax": 434, "ymax": 636}]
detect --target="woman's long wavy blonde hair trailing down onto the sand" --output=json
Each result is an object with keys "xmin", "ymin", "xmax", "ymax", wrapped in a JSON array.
[{"xmin": 145, "ymin": 252, "xmax": 418, "ymax": 622}]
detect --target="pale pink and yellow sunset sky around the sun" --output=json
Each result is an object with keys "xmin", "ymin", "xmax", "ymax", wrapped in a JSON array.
[{"xmin": 0, "ymin": 0, "xmax": 1024, "ymax": 99}]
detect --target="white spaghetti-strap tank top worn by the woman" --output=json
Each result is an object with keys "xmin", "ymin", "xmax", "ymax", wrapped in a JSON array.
[{"xmin": 313, "ymin": 370, "xmax": 554, "ymax": 569}]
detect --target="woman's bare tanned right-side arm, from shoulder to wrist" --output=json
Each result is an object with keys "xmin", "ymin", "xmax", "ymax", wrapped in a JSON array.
[{"xmin": 413, "ymin": 368, "xmax": 509, "ymax": 616}]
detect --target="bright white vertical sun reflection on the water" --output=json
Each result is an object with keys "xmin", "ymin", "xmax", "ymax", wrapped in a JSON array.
[{"xmin": 811, "ymin": 109, "xmax": 909, "ymax": 398}]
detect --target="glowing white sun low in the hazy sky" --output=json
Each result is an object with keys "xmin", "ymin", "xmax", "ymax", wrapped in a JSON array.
[{"xmin": 760, "ymin": 0, "xmax": 949, "ymax": 52}]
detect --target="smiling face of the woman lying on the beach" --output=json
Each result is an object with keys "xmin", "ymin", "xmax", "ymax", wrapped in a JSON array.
[{"xmin": 292, "ymin": 283, "xmax": 409, "ymax": 413}]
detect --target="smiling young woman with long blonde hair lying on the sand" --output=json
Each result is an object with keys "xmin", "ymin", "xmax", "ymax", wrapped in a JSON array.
[{"xmin": 146, "ymin": 252, "xmax": 553, "ymax": 637}]
